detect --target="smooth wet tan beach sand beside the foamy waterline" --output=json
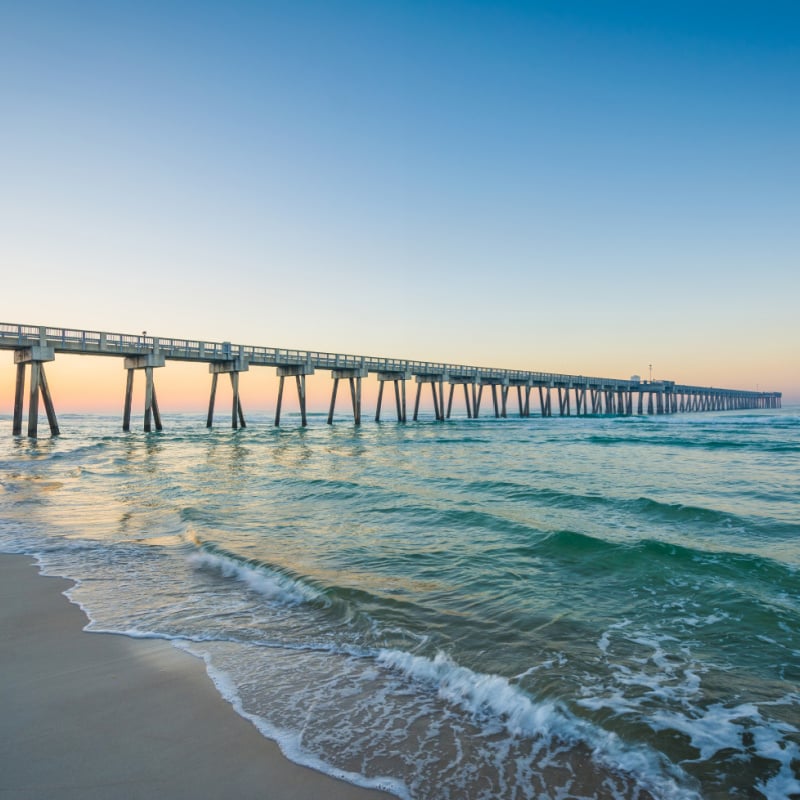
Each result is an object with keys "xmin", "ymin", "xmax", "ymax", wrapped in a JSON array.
[{"xmin": 0, "ymin": 555, "xmax": 392, "ymax": 800}]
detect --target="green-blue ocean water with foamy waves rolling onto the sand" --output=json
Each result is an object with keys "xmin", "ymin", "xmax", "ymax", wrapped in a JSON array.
[{"xmin": 0, "ymin": 408, "xmax": 800, "ymax": 800}]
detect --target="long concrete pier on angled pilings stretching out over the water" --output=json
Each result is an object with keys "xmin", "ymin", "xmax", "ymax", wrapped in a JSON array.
[{"xmin": 0, "ymin": 323, "xmax": 781, "ymax": 438}]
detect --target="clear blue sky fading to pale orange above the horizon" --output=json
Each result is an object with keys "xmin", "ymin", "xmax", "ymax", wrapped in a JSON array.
[{"xmin": 0, "ymin": 0, "xmax": 800, "ymax": 413}]
